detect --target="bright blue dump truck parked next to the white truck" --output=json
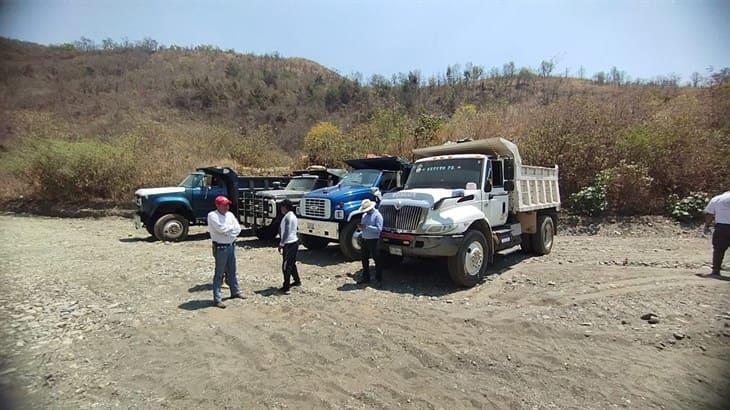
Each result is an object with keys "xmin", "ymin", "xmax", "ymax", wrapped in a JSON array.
[{"xmin": 297, "ymin": 157, "xmax": 411, "ymax": 259}]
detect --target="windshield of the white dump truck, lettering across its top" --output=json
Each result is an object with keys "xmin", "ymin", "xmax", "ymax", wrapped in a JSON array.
[{"xmin": 405, "ymin": 158, "xmax": 482, "ymax": 189}]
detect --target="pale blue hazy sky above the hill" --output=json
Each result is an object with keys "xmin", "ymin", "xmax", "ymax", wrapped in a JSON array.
[{"xmin": 0, "ymin": 0, "xmax": 730, "ymax": 79}]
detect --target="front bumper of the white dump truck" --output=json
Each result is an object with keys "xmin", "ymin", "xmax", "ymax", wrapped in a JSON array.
[{"xmin": 381, "ymin": 232, "xmax": 464, "ymax": 257}]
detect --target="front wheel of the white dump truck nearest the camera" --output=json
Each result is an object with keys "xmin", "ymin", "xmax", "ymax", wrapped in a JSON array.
[{"xmin": 448, "ymin": 230, "xmax": 490, "ymax": 288}]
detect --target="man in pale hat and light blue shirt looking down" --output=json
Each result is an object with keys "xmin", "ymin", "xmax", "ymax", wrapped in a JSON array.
[{"xmin": 357, "ymin": 199, "xmax": 383, "ymax": 286}]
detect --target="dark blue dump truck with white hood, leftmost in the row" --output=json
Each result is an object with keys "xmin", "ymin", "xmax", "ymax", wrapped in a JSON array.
[{"xmin": 134, "ymin": 167, "xmax": 292, "ymax": 241}]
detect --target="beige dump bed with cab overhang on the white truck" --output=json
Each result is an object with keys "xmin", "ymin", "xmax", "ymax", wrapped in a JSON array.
[{"xmin": 413, "ymin": 138, "xmax": 560, "ymax": 212}]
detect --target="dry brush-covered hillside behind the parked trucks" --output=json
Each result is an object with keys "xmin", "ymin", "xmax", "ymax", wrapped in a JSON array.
[{"xmin": 0, "ymin": 38, "xmax": 730, "ymax": 212}]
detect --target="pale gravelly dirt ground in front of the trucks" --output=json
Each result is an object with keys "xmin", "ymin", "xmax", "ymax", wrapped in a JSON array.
[{"xmin": 0, "ymin": 216, "xmax": 730, "ymax": 409}]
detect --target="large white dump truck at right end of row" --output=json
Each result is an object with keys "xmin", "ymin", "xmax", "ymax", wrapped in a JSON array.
[{"xmin": 379, "ymin": 138, "xmax": 560, "ymax": 287}]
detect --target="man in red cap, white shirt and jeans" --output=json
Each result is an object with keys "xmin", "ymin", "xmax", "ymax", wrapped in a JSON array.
[{"xmin": 208, "ymin": 195, "xmax": 245, "ymax": 309}]
